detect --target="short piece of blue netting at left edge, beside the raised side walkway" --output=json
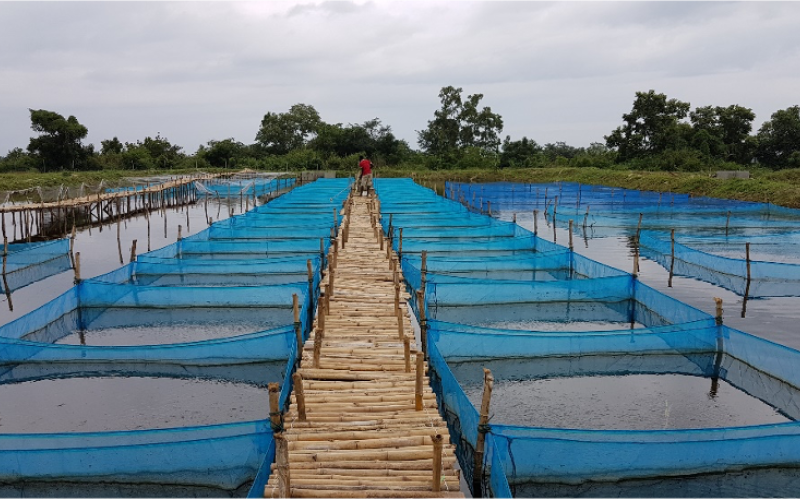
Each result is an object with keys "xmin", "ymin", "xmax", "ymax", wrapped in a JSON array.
[{"xmin": 0, "ymin": 239, "xmax": 72, "ymax": 293}]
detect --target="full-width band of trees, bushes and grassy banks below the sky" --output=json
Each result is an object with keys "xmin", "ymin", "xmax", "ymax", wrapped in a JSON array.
[{"xmin": 0, "ymin": 86, "xmax": 800, "ymax": 206}]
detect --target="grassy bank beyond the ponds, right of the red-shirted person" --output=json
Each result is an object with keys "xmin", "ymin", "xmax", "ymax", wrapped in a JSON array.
[{"xmin": 377, "ymin": 168, "xmax": 800, "ymax": 208}]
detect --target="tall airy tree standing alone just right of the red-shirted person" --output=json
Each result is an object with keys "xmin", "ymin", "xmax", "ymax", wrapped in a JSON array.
[{"xmin": 417, "ymin": 86, "xmax": 503, "ymax": 159}]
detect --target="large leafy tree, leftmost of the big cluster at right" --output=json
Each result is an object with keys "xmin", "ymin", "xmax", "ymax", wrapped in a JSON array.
[{"xmin": 605, "ymin": 90, "xmax": 691, "ymax": 161}]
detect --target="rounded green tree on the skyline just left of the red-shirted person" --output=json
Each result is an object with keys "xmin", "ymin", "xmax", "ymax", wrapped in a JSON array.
[{"xmin": 256, "ymin": 104, "xmax": 322, "ymax": 155}]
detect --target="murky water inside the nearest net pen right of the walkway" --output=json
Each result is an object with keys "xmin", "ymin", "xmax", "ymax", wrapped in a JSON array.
[{"xmin": 465, "ymin": 374, "xmax": 790, "ymax": 430}]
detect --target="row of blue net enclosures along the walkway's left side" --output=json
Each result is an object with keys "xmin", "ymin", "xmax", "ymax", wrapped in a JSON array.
[{"xmin": 0, "ymin": 179, "xmax": 352, "ymax": 498}]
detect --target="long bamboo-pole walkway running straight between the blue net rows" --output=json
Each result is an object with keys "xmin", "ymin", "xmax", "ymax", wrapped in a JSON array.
[{"xmin": 264, "ymin": 192, "xmax": 464, "ymax": 499}]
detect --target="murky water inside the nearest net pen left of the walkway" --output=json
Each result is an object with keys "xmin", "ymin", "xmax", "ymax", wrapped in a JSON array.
[{"xmin": 0, "ymin": 377, "xmax": 269, "ymax": 434}]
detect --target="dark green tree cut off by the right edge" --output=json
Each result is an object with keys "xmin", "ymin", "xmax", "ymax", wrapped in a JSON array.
[{"xmin": 756, "ymin": 106, "xmax": 800, "ymax": 169}]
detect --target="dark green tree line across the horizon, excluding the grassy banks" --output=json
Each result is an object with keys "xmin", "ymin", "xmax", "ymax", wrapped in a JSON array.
[{"xmin": 0, "ymin": 86, "xmax": 800, "ymax": 172}]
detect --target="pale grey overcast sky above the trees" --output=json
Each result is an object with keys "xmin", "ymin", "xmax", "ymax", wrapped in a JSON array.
[{"xmin": 0, "ymin": 0, "xmax": 800, "ymax": 155}]
